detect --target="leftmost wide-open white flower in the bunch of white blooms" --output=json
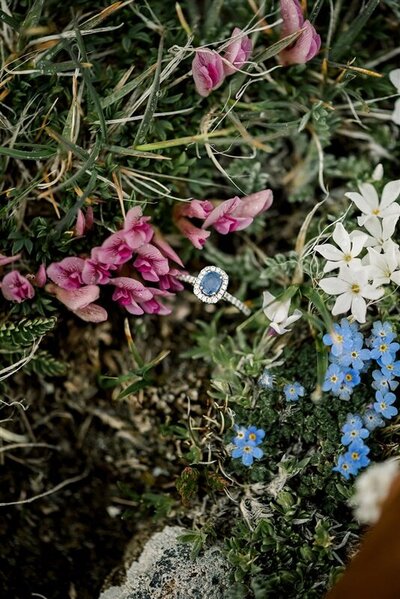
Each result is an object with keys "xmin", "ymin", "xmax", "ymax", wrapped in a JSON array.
[{"xmin": 315, "ymin": 223, "xmax": 368, "ymax": 272}]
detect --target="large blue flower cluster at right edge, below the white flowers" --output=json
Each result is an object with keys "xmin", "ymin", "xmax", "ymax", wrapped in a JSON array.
[{"xmin": 332, "ymin": 319, "xmax": 400, "ymax": 480}]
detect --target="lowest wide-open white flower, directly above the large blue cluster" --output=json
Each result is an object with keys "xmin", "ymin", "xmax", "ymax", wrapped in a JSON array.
[{"xmin": 318, "ymin": 266, "xmax": 384, "ymax": 322}]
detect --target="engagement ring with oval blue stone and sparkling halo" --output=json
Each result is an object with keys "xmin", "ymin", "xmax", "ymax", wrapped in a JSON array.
[{"xmin": 177, "ymin": 266, "xmax": 251, "ymax": 316}]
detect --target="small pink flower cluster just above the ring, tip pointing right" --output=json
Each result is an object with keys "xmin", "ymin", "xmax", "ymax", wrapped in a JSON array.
[{"xmin": 174, "ymin": 189, "xmax": 273, "ymax": 250}]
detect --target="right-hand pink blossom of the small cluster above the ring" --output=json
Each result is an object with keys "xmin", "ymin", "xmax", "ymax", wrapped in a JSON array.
[{"xmin": 203, "ymin": 189, "xmax": 272, "ymax": 235}]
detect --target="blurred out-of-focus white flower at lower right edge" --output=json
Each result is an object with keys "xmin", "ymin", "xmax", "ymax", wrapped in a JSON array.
[{"xmin": 350, "ymin": 459, "xmax": 400, "ymax": 524}]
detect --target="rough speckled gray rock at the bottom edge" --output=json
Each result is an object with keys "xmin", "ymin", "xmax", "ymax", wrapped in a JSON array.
[{"xmin": 99, "ymin": 526, "xmax": 230, "ymax": 599}]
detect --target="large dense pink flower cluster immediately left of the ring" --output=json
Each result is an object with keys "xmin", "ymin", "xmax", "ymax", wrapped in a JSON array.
[{"xmin": 46, "ymin": 206, "xmax": 183, "ymax": 322}]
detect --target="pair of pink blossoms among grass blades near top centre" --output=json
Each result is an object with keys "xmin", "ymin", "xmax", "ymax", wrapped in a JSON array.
[{"xmin": 192, "ymin": 27, "xmax": 253, "ymax": 97}]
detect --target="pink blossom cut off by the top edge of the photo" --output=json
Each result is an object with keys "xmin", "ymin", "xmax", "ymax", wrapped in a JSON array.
[{"xmin": 279, "ymin": 0, "xmax": 321, "ymax": 66}]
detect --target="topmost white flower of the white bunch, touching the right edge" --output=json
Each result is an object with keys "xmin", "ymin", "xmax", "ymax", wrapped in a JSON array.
[{"xmin": 345, "ymin": 179, "xmax": 400, "ymax": 227}]
